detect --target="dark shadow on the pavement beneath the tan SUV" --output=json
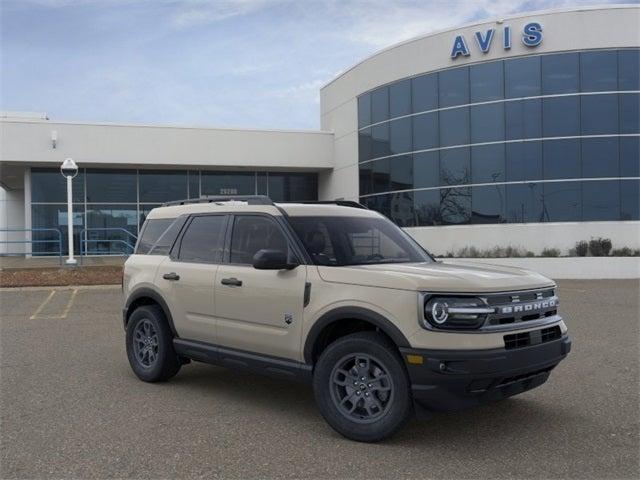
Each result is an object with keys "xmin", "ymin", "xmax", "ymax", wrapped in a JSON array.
[{"xmin": 154, "ymin": 363, "xmax": 575, "ymax": 447}]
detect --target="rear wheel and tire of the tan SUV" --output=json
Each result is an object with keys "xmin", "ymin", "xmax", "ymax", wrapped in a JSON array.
[{"xmin": 126, "ymin": 305, "xmax": 181, "ymax": 382}]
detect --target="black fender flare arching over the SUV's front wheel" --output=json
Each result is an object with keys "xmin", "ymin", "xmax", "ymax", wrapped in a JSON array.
[{"xmin": 303, "ymin": 307, "xmax": 411, "ymax": 365}]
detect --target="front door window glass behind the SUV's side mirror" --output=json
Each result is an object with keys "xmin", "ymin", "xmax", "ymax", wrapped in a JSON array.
[{"xmin": 230, "ymin": 215, "xmax": 289, "ymax": 264}]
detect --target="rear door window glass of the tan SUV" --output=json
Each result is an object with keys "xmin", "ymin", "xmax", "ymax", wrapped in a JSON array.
[{"xmin": 178, "ymin": 215, "xmax": 227, "ymax": 263}]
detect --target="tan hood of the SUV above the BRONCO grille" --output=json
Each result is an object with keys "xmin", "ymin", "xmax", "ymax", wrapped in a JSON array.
[{"xmin": 318, "ymin": 262, "xmax": 554, "ymax": 293}]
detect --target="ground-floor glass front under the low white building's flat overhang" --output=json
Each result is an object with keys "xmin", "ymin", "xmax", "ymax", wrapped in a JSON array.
[{"xmin": 31, "ymin": 168, "xmax": 318, "ymax": 255}]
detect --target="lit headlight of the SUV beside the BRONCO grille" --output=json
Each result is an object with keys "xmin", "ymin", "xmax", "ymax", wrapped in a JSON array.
[{"xmin": 423, "ymin": 297, "xmax": 495, "ymax": 330}]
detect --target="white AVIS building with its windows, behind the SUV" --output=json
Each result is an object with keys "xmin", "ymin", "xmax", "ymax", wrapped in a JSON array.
[{"xmin": 0, "ymin": 6, "xmax": 640, "ymax": 254}]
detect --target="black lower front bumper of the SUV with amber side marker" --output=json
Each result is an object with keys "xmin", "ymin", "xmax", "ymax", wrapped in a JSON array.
[{"xmin": 400, "ymin": 335, "xmax": 571, "ymax": 411}]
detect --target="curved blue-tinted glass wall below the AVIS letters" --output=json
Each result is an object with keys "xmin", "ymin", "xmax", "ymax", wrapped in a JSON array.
[{"xmin": 357, "ymin": 48, "xmax": 640, "ymax": 227}]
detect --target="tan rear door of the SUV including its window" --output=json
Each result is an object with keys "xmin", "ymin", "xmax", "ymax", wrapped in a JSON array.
[{"xmin": 156, "ymin": 215, "xmax": 229, "ymax": 343}]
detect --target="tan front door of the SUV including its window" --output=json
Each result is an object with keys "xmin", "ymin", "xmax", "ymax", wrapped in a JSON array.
[{"xmin": 215, "ymin": 215, "xmax": 307, "ymax": 360}]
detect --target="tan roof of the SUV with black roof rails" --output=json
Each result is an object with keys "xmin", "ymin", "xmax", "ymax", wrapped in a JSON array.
[{"xmin": 147, "ymin": 201, "xmax": 380, "ymax": 219}]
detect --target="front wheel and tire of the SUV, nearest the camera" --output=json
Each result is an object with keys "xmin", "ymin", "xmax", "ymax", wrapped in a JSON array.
[{"xmin": 313, "ymin": 332, "xmax": 413, "ymax": 442}]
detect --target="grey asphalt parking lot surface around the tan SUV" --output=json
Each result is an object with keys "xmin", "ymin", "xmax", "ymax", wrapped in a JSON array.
[{"xmin": 0, "ymin": 280, "xmax": 640, "ymax": 480}]
